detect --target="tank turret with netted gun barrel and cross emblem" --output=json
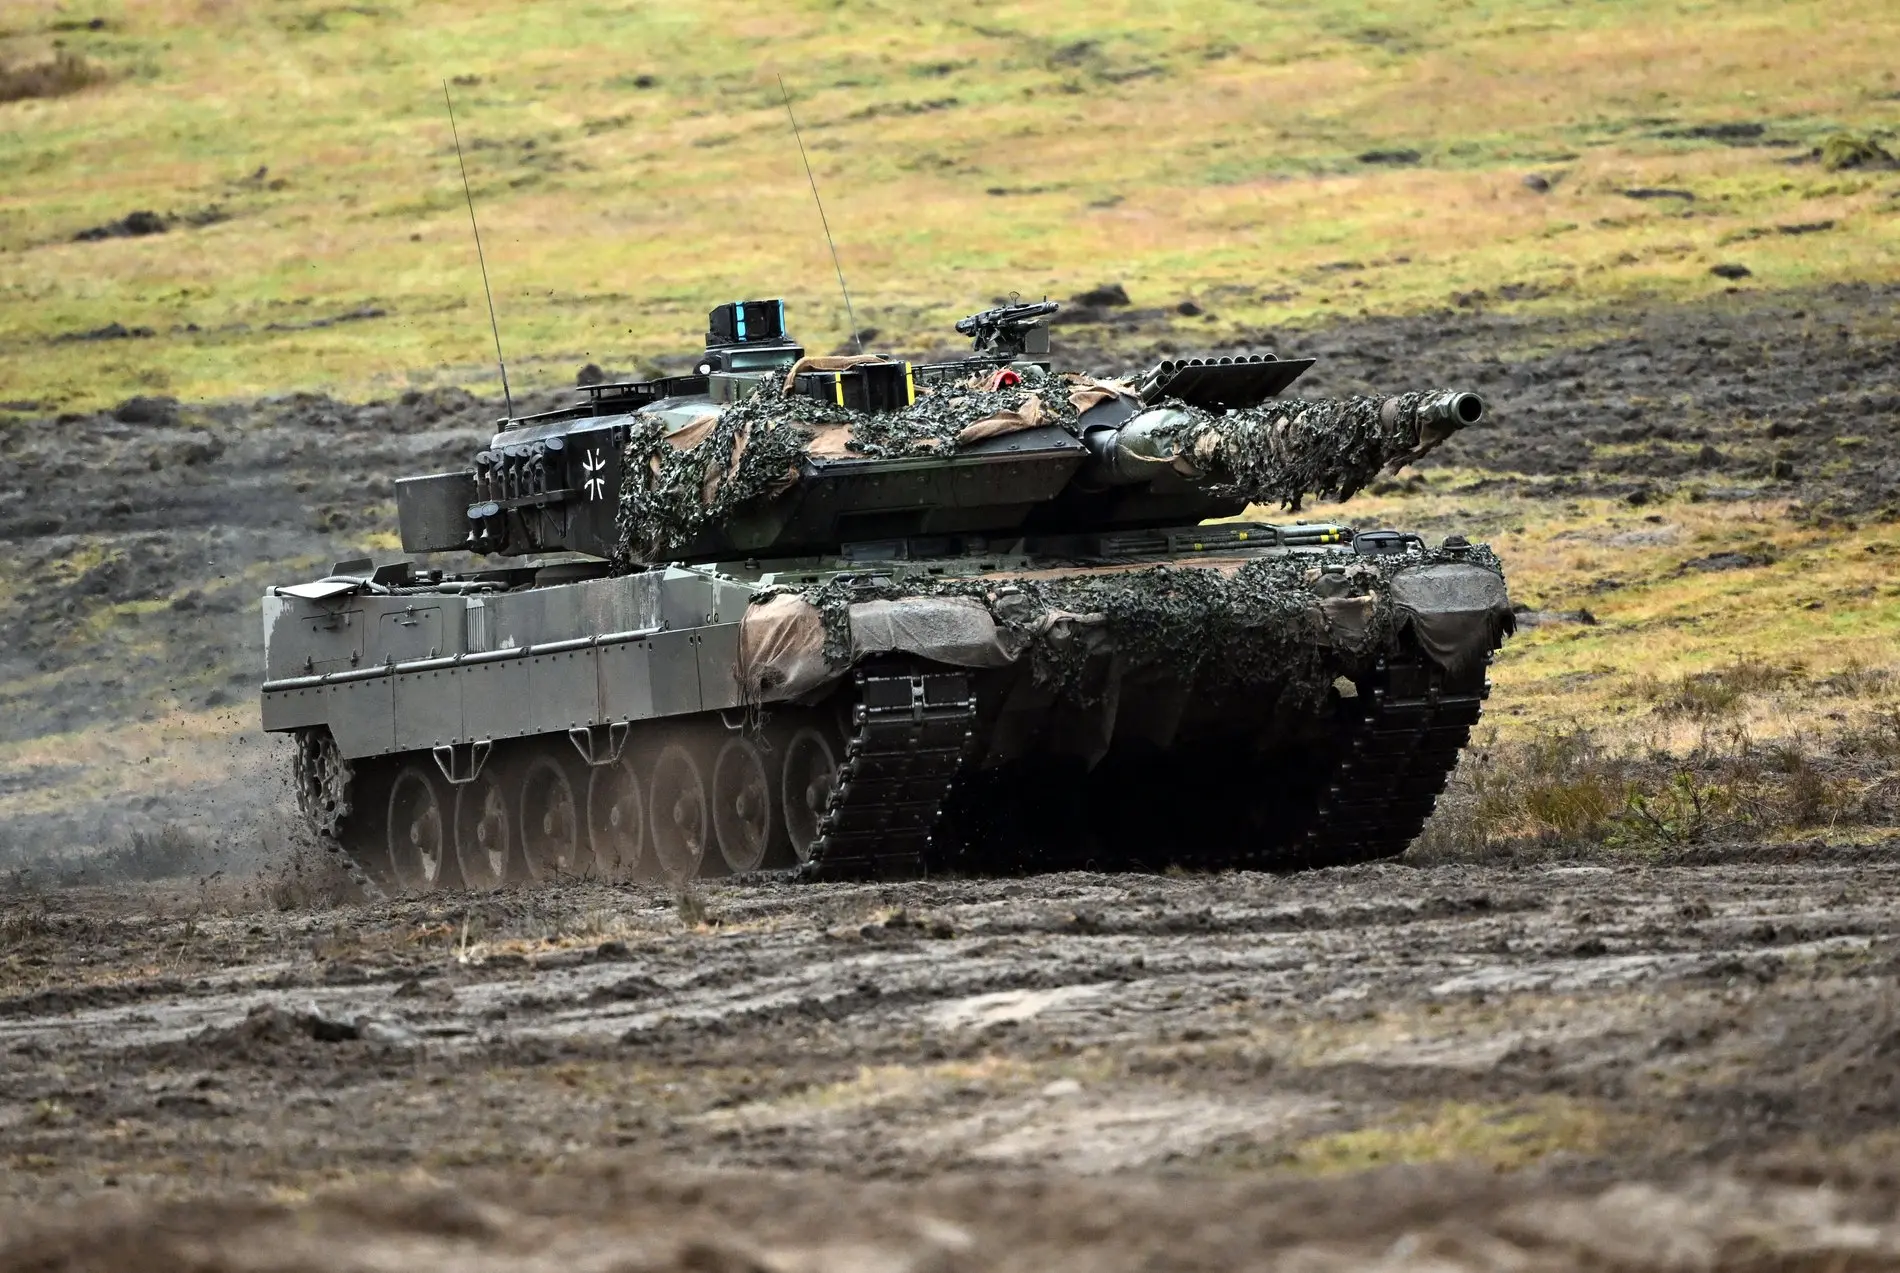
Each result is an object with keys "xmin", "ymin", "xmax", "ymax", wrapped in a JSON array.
[{"xmin": 397, "ymin": 300, "xmax": 1484, "ymax": 566}]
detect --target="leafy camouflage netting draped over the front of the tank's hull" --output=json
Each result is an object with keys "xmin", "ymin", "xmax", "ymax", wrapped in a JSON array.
[{"xmin": 779, "ymin": 547, "xmax": 1503, "ymax": 707}]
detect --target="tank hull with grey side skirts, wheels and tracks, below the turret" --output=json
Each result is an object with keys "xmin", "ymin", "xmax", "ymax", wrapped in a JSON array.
[{"xmin": 262, "ymin": 524, "xmax": 1511, "ymax": 889}]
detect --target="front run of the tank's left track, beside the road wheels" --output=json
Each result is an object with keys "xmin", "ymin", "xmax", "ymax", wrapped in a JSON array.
[{"xmin": 800, "ymin": 667, "xmax": 977, "ymax": 880}]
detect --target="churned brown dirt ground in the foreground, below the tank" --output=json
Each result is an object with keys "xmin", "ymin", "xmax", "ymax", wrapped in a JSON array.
[{"xmin": 0, "ymin": 862, "xmax": 1900, "ymax": 1269}]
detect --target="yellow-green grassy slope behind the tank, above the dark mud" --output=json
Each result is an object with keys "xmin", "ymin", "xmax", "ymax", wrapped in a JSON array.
[{"xmin": 0, "ymin": 0, "xmax": 1900, "ymax": 420}]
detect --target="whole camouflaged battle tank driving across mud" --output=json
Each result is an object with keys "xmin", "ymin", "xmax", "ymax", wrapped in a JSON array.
[{"xmin": 262, "ymin": 300, "xmax": 1512, "ymax": 891}]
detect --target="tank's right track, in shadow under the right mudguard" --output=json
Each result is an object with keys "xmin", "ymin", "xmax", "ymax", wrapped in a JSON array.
[{"xmin": 1258, "ymin": 659, "xmax": 1490, "ymax": 870}]
